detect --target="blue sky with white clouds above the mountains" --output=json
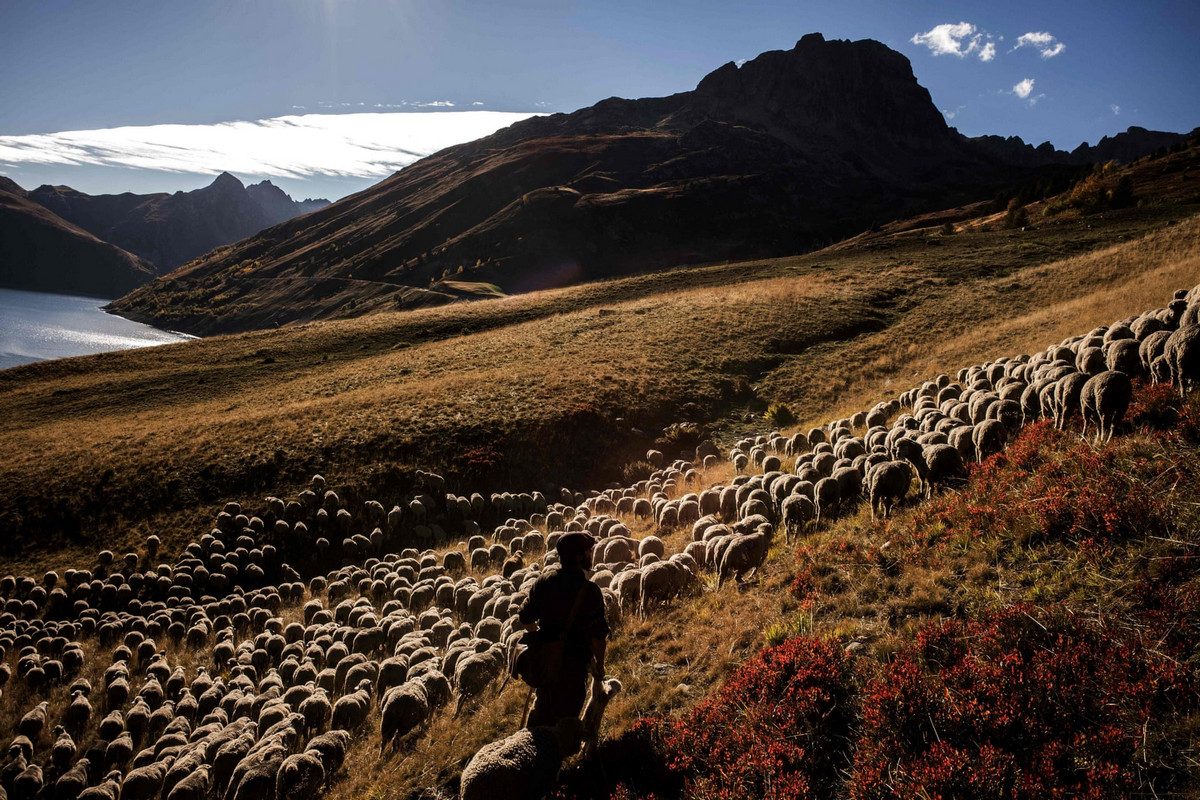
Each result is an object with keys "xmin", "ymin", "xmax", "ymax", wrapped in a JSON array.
[{"xmin": 0, "ymin": 0, "xmax": 1200, "ymax": 199}]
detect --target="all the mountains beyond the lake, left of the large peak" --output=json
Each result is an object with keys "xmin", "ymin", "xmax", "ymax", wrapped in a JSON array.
[{"xmin": 0, "ymin": 173, "xmax": 329, "ymax": 297}]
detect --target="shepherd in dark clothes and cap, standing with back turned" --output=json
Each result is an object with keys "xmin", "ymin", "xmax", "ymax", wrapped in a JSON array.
[{"xmin": 520, "ymin": 531, "xmax": 608, "ymax": 729}]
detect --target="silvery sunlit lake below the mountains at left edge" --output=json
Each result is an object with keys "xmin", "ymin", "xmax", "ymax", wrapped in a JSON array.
[{"xmin": 0, "ymin": 289, "xmax": 196, "ymax": 369}]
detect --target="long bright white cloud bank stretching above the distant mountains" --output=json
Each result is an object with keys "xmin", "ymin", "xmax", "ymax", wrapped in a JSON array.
[{"xmin": 0, "ymin": 112, "xmax": 535, "ymax": 178}]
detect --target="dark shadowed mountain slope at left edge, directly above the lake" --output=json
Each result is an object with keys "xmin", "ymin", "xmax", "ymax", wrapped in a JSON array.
[{"xmin": 0, "ymin": 178, "xmax": 155, "ymax": 297}]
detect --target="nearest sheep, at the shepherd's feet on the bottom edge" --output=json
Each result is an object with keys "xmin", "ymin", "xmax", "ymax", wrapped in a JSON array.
[{"xmin": 458, "ymin": 717, "xmax": 583, "ymax": 800}]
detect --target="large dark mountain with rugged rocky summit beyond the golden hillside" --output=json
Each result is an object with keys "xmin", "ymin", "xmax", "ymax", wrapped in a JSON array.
[{"xmin": 105, "ymin": 34, "xmax": 1190, "ymax": 333}]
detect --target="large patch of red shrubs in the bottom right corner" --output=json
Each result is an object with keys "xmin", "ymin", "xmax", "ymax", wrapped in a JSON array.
[{"xmin": 851, "ymin": 607, "xmax": 1195, "ymax": 800}]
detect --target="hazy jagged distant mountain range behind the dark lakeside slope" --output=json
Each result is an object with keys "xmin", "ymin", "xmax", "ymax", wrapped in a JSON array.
[{"xmin": 26, "ymin": 173, "xmax": 328, "ymax": 272}]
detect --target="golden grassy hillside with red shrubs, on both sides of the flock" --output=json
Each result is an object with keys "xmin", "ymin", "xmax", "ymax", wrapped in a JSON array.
[{"xmin": 0, "ymin": 140, "xmax": 1200, "ymax": 800}]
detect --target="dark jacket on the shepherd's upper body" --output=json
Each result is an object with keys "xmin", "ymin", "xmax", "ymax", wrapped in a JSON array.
[{"xmin": 520, "ymin": 567, "xmax": 608, "ymax": 661}]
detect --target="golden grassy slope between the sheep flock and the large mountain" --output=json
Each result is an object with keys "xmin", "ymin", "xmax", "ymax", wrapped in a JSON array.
[{"xmin": 0, "ymin": 142, "xmax": 1200, "ymax": 575}]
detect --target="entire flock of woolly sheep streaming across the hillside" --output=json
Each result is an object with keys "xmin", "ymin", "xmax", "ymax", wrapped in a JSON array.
[{"xmin": 0, "ymin": 287, "xmax": 1200, "ymax": 800}]
